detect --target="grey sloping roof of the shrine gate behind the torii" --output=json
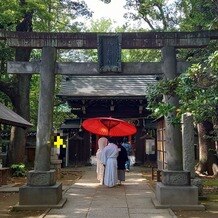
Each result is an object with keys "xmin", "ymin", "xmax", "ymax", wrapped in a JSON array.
[{"xmin": 58, "ymin": 75, "xmax": 157, "ymax": 98}]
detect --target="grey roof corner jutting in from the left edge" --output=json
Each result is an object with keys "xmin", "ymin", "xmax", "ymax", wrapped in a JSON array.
[{"xmin": 0, "ymin": 103, "xmax": 32, "ymax": 128}]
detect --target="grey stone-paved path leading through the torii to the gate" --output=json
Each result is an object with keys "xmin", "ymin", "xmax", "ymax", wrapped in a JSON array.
[{"xmin": 43, "ymin": 166, "xmax": 176, "ymax": 218}]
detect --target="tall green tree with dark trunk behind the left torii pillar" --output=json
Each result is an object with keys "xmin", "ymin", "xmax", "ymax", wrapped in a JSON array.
[{"xmin": 0, "ymin": 0, "xmax": 91, "ymax": 163}]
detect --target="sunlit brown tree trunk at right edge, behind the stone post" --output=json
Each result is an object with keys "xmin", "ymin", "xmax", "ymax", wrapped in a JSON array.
[{"xmin": 196, "ymin": 121, "xmax": 216, "ymax": 175}]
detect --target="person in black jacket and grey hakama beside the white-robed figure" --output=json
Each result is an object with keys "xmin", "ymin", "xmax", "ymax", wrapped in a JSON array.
[{"xmin": 117, "ymin": 141, "xmax": 128, "ymax": 185}]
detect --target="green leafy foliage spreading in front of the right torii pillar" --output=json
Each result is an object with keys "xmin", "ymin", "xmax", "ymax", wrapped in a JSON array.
[{"xmin": 148, "ymin": 51, "xmax": 218, "ymax": 123}]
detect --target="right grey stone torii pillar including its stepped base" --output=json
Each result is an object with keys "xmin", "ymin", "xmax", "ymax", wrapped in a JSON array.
[{"xmin": 153, "ymin": 46, "xmax": 204, "ymax": 210}]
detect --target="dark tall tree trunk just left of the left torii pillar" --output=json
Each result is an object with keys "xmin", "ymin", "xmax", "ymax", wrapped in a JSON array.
[{"xmin": 9, "ymin": 0, "xmax": 33, "ymax": 163}]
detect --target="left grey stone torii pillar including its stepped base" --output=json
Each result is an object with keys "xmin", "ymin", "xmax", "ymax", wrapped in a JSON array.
[{"xmin": 15, "ymin": 47, "xmax": 66, "ymax": 209}]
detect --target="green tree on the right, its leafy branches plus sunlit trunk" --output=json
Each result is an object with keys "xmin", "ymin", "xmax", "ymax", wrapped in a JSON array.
[{"xmin": 148, "ymin": 52, "xmax": 218, "ymax": 176}]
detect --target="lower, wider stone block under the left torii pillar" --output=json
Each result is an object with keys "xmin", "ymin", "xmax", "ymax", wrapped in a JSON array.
[{"xmin": 14, "ymin": 183, "xmax": 66, "ymax": 210}]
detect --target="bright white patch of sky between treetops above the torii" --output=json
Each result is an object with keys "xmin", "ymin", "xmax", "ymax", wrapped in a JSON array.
[{"xmin": 84, "ymin": 0, "xmax": 129, "ymax": 25}]
